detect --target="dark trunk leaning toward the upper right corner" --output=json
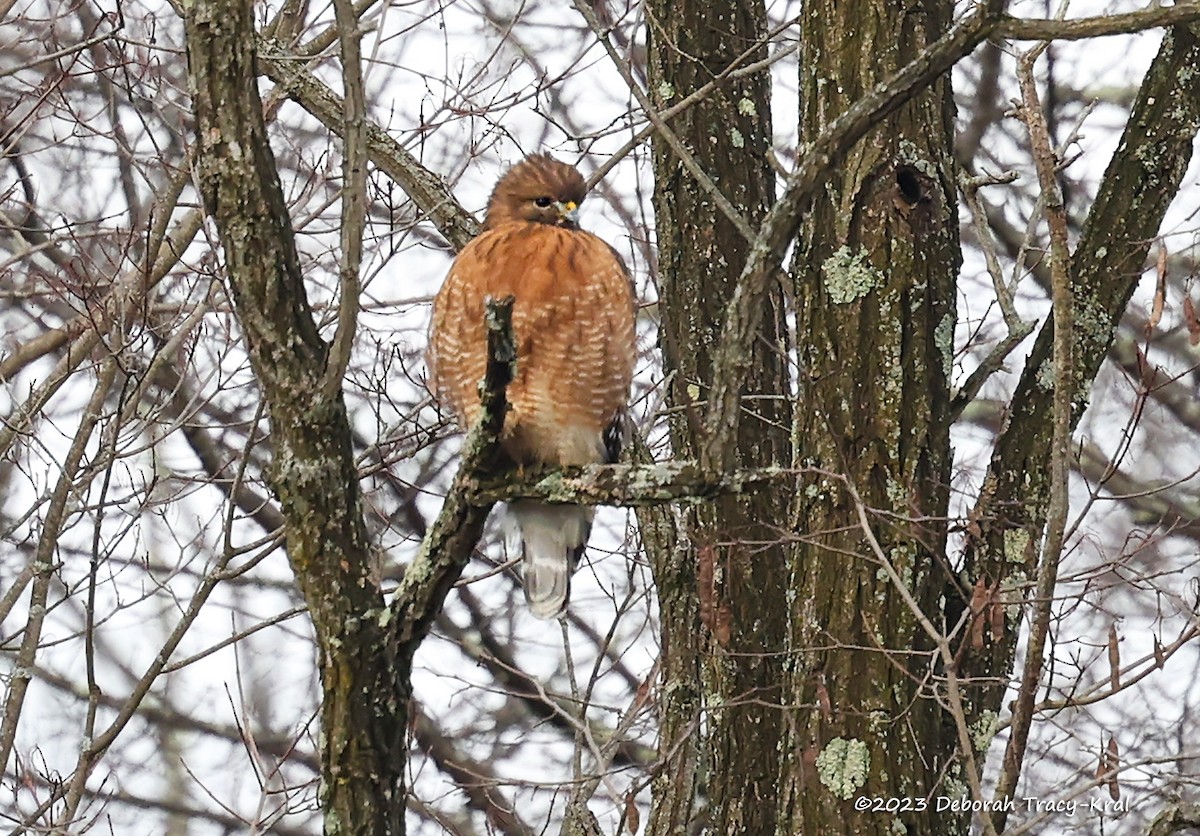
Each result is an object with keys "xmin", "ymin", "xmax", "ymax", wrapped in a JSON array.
[{"xmin": 962, "ymin": 19, "xmax": 1200, "ymax": 716}]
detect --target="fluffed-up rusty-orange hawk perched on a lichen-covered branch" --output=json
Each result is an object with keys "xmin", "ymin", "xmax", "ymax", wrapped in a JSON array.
[{"xmin": 427, "ymin": 155, "xmax": 636, "ymax": 618}]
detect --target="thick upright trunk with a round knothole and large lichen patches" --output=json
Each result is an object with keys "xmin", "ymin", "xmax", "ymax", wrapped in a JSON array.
[{"xmin": 779, "ymin": 0, "xmax": 966, "ymax": 834}]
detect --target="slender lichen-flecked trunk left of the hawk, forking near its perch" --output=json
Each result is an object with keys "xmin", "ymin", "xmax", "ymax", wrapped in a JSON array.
[{"xmin": 187, "ymin": 0, "xmax": 409, "ymax": 836}]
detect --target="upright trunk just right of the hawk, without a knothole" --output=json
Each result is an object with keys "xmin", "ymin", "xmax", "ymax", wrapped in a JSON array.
[{"xmin": 642, "ymin": 0, "xmax": 791, "ymax": 836}]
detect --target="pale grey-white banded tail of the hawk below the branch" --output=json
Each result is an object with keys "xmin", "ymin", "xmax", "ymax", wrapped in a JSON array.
[{"xmin": 509, "ymin": 500, "xmax": 595, "ymax": 619}]
